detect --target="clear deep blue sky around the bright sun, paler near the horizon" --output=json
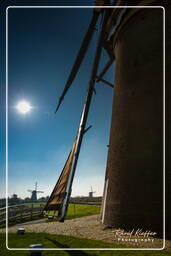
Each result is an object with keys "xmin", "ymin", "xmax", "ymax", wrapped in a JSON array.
[{"xmin": 0, "ymin": 1, "xmax": 114, "ymax": 198}]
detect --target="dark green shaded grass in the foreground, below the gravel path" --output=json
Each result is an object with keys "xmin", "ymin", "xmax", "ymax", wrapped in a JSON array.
[{"xmin": 0, "ymin": 233, "xmax": 170, "ymax": 256}]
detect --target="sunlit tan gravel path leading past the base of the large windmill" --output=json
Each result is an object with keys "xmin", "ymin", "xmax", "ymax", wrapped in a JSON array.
[{"xmin": 0, "ymin": 215, "xmax": 171, "ymax": 249}]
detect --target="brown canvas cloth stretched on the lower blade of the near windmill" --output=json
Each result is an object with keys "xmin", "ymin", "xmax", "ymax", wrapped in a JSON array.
[{"xmin": 44, "ymin": 140, "xmax": 76, "ymax": 211}]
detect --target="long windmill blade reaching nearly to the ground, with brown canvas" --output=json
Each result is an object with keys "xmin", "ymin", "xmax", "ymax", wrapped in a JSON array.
[{"xmin": 44, "ymin": 4, "xmax": 108, "ymax": 222}]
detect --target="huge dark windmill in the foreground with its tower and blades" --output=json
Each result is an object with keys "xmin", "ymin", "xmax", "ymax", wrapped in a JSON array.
[{"xmin": 44, "ymin": 0, "xmax": 164, "ymax": 238}]
